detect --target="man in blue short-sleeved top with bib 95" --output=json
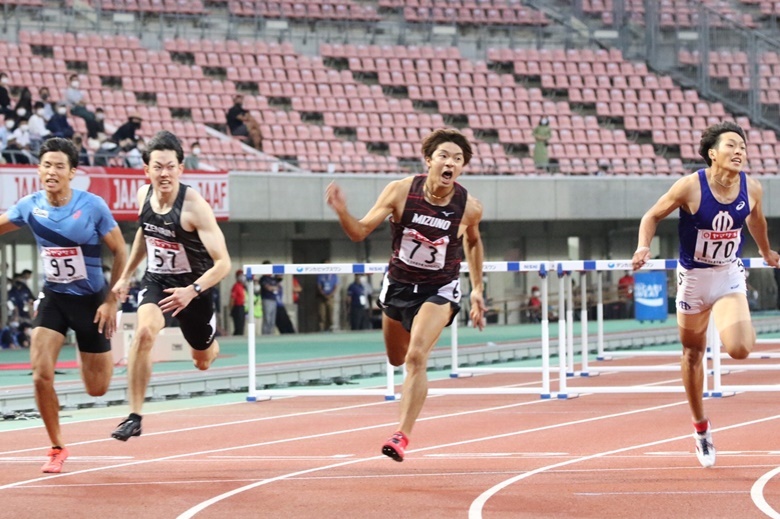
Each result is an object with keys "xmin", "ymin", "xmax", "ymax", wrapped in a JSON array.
[{"xmin": 0, "ymin": 138, "xmax": 127, "ymax": 473}]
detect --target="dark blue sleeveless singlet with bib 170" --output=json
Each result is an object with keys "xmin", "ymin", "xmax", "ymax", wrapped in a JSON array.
[{"xmin": 678, "ymin": 169, "xmax": 750, "ymax": 269}]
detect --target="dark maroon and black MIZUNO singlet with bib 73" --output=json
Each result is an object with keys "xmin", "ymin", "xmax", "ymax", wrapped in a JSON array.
[{"xmin": 388, "ymin": 175, "xmax": 468, "ymax": 285}]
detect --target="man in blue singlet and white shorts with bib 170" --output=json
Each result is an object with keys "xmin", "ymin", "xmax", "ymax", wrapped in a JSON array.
[{"xmin": 633, "ymin": 122, "xmax": 778, "ymax": 467}]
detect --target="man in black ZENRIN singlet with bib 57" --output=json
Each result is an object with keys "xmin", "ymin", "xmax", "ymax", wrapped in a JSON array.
[{"xmin": 111, "ymin": 131, "xmax": 230, "ymax": 441}]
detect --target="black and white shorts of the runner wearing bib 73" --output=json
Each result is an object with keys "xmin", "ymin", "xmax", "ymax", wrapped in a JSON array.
[{"xmin": 377, "ymin": 275, "xmax": 460, "ymax": 332}]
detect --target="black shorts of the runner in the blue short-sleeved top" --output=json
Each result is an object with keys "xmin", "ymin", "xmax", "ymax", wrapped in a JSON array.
[{"xmin": 33, "ymin": 288, "xmax": 111, "ymax": 353}]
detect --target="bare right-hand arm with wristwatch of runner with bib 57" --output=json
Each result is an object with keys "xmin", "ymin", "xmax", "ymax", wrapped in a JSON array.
[{"xmin": 160, "ymin": 190, "xmax": 231, "ymax": 316}]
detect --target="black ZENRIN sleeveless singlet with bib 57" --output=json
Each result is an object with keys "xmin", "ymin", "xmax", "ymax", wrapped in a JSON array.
[{"xmin": 138, "ymin": 184, "xmax": 214, "ymax": 287}]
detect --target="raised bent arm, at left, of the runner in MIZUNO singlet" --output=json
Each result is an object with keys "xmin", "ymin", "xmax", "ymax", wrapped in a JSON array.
[{"xmin": 325, "ymin": 179, "xmax": 410, "ymax": 241}]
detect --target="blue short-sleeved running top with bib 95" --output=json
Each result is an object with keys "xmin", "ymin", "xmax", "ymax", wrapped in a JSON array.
[{"xmin": 8, "ymin": 189, "xmax": 117, "ymax": 295}]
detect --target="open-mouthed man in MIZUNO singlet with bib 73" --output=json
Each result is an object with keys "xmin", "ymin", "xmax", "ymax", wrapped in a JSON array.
[{"xmin": 325, "ymin": 129, "xmax": 485, "ymax": 461}]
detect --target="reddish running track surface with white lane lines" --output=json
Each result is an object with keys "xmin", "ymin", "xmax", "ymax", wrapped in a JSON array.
[{"xmin": 0, "ymin": 366, "xmax": 780, "ymax": 519}]
